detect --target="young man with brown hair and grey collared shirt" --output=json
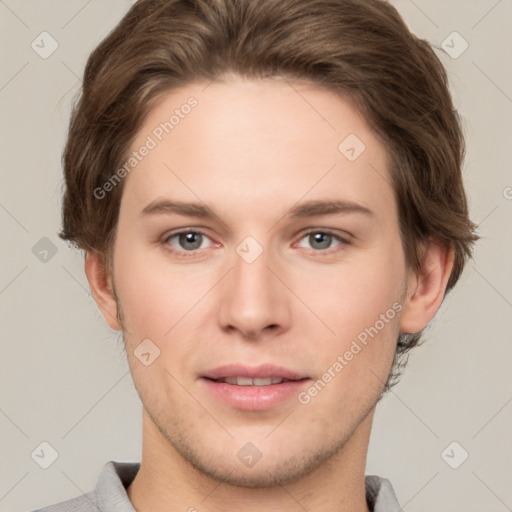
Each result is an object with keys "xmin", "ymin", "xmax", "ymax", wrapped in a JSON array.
[{"xmin": 34, "ymin": 0, "xmax": 477, "ymax": 512}]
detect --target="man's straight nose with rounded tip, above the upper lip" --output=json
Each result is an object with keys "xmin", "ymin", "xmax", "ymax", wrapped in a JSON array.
[{"xmin": 218, "ymin": 242, "xmax": 291, "ymax": 341}]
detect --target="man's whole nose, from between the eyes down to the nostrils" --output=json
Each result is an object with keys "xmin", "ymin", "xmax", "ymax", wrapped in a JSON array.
[{"xmin": 220, "ymin": 237, "xmax": 290, "ymax": 337}]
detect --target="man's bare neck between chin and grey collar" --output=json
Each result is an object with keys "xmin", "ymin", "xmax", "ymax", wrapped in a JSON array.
[{"xmin": 127, "ymin": 410, "xmax": 374, "ymax": 512}]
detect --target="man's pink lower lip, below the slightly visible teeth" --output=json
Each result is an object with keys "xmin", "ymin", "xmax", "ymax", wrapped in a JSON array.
[{"xmin": 201, "ymin": 378, "xmax": 311, "ymax": 411}]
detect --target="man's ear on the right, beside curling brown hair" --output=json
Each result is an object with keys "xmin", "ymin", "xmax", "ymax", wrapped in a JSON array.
[{"xmin": 400, "ymin": 241, "xmax": 454, "ymax": 333}]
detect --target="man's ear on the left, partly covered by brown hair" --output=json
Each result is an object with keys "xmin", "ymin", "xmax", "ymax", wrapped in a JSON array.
[{"xmin": 85, "ymin": 251, "xmax": 122, "ymax": 331}]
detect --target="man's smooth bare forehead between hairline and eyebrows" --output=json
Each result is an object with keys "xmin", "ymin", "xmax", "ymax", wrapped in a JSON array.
[{"xmin": 119, "ymin": 77, "xmax": 393, "ymax": 222}]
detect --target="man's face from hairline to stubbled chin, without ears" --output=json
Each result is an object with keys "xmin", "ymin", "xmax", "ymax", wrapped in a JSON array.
[{"xmin": 106, "ymin": 77, "xmax": 407, "ymax": 487}]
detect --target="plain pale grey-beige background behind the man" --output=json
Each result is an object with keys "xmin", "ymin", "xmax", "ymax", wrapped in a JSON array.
[{"xmin": 0, "ymin": 0, "xmax": 512, "ymax": 512}]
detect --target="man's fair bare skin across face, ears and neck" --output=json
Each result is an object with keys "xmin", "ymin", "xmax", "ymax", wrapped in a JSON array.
[{"xmin": 86, "ymin": 75, "xmax": 453, "ymax": 512}]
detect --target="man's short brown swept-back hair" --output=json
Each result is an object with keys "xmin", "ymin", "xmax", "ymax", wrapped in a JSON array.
[{"xmin": 59, "ymin": 0, "xmax": 479, "ymax": 389}]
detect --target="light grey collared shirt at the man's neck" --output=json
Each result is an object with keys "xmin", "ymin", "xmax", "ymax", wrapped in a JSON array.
[{"xmin": 34, "ymin": 460, "xmax": 404, "ymax": 512}]
